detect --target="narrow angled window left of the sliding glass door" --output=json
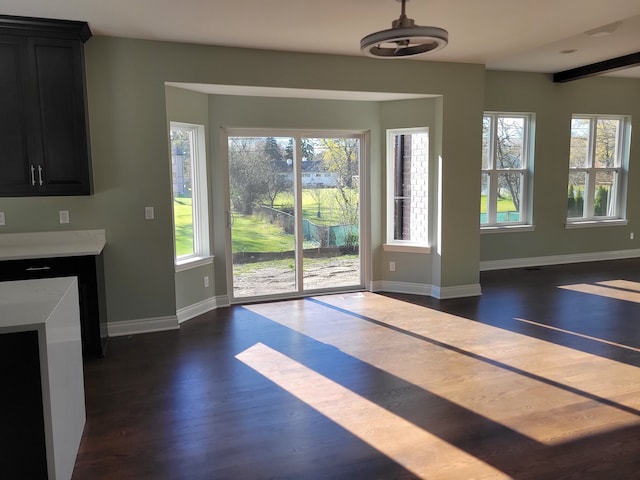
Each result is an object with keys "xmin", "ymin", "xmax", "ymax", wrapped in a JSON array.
[{"xmin": 170, "ymin": 122, "xmax": 209, "ymax": 265}]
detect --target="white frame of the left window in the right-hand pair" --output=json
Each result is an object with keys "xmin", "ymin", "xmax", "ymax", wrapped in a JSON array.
[{"xmin": 480, "ymin": 111, "xmax": 535, "ymax": 233}]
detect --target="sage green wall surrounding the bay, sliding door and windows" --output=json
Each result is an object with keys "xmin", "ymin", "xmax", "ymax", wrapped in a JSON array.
[{"xmin": 0, "ymin": 33, "xmax": 640, "ymax": 322}]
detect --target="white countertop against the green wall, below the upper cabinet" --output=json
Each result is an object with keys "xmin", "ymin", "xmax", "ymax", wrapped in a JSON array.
[{"xmin": 0, "ymin": 230, "xmax": 106, "ymax": 260}]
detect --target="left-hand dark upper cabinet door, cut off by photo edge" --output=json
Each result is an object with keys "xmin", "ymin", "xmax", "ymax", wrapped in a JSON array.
[{"xmin": 0, "ymin": 35, "xmax": 34, "ymax": 194}]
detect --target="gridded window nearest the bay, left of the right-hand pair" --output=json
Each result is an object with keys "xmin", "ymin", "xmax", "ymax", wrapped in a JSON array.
[{"xmin": 480, "ymin": 113, "xmax": 532, "ymax": 227}]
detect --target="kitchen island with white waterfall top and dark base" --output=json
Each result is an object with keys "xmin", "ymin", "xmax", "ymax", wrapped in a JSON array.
[{"xmin": 0, "ymin": 277, "xmax": 86, "ymax": 480}]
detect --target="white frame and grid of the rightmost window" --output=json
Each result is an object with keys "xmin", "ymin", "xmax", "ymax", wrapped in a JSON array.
[{"xmin": 565, "ymin": 114, "xmax": 631, "ymax": 228}]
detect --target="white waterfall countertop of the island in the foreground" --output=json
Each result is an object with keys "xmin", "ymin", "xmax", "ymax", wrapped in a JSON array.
[{"xmin": 0, "ymin": 277, "xmax": 86, "ymax": 480}]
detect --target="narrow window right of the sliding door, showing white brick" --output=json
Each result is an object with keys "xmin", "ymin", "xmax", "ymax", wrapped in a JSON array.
[{"xmin": 387, "ymin": 128, "xmax": 429, "ymax": 247}]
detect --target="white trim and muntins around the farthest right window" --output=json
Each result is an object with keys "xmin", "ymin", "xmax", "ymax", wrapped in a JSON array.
[{"xmin": 565, "ymin": 114, "xmax": 631, "ymax": 225}]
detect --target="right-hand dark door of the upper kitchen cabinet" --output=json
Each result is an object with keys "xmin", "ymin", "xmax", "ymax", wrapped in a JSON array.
[{"xmin": 28, "ymin": 38, "xmax": 91, "ymax": 195}]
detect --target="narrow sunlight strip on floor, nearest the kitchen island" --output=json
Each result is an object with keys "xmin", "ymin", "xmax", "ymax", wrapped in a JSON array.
[{"xmin": 236, "ymin": 343, "xmax": 509, "ymax": 479}]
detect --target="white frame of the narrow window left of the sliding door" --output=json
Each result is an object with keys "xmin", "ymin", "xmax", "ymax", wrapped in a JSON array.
[{"xmin": 169, "ymin": 121, "xmax": 213, "ymax": 271}]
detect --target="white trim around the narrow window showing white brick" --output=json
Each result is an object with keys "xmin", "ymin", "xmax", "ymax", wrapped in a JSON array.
[{"xmin": 383, "ymin": 127, "xmax": 431, "ymax": 249}]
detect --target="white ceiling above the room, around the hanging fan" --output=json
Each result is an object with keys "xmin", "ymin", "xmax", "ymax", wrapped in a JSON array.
[{"xmin": 0, "ymin": 0, "xmax": 640, "ymax": 78}]
